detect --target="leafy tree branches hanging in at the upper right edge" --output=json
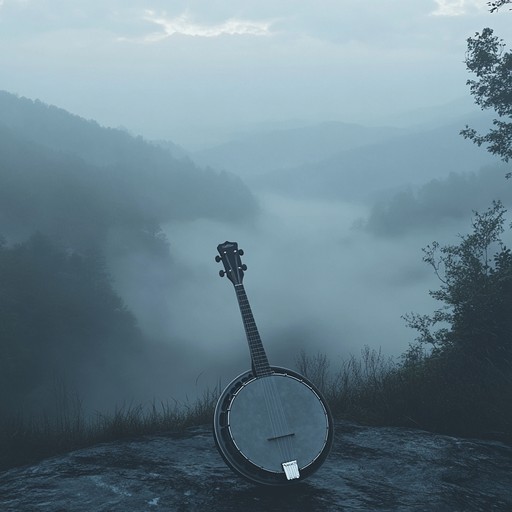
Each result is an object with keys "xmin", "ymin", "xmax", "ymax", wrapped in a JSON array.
[{"xmin": 461, "ymin": 28, "xmax": 512, "ymax": 178}]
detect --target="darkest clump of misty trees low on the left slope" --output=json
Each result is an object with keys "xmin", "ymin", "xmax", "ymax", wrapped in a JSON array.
[{"xmin": 0, "ymin": 233, "xmax": 143, "ymax": 418}]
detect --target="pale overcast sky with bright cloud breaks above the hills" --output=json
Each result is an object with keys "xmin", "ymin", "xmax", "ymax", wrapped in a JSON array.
[{"xmin": 0, "ymin": 0, "xmax": 511, "ymax": 145}]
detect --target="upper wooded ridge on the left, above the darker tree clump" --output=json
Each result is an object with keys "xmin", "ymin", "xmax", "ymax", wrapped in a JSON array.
[{"xmin": 0, "ymin": 92, "xmax": 257, "ymax": 245}]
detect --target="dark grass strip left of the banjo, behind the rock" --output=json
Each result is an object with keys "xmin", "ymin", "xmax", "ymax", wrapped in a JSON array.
[{"xmin": 0, "ymin": 386, "xmax": 219, "ymax": 470}]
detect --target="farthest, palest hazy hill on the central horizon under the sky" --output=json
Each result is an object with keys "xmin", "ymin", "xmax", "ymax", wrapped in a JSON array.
[{"xmin": 191, "ymin": 122, "xmax": 403, "ymax": 176}]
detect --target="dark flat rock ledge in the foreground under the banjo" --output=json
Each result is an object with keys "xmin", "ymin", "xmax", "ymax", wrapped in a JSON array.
[{"xmin": 0, "ymin": 422, "xmax": 512, "ymax": 512}]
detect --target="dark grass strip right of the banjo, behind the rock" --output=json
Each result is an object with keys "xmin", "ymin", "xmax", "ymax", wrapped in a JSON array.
[{"xmin": 297, "ymin": 346, "xmax": 512, "ymax": 442}]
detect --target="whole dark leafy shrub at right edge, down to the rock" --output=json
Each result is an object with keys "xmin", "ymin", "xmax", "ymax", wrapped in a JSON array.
[{"xmin": 396, "ymin": 202, "xmax": 512, "ymax": 436}]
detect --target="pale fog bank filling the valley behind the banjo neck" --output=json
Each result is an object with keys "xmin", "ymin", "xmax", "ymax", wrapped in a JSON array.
[{"xmin": 109, "ymin": 189, "xmax": 480, "ymax": 399}]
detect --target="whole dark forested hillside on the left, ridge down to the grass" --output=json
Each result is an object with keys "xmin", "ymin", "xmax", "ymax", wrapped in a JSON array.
[{"xmin": 0, "ymin": 92, "xmax": 258, "ymax": 428}]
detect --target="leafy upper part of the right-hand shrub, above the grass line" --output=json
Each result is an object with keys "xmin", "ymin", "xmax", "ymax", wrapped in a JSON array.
[{"xmin": 405, "ymin": 201, "xmax": 512, "ymax": 365}]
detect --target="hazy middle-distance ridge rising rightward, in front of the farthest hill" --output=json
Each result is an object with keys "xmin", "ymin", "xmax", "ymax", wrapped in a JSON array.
[{"xmin": 257, "ymin": 116, "xmax": 497, "ymax": 199}]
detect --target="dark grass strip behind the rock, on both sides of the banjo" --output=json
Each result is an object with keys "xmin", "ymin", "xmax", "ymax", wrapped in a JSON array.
[{"xmin": 0, "ymin": 347, "xmax": 512, "ymax": 469}]
